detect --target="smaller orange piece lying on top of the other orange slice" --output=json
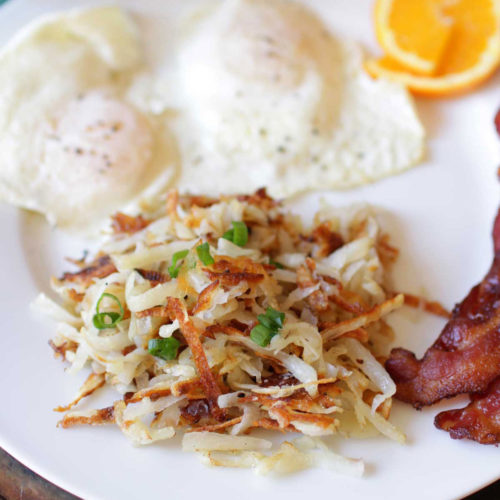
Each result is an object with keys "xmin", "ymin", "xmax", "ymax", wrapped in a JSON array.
[{"xmin": 375, "ymin": 0, "xmax": 452, "ymax": 75}]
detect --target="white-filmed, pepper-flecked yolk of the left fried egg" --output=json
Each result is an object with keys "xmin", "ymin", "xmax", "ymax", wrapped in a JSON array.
[{"xmin": 45, "ymin": 91, "xmax": 153, "ymax": 192}]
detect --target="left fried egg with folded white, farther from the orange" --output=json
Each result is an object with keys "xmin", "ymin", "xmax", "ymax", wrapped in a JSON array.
[{"xmin": 0, "ymin": 7, "xmax": 178, "ymax": 229}]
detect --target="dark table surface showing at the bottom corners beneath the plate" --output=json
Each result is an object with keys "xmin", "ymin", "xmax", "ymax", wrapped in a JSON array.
[{"xmin": 0, "ymin": 446, "xmax": 500, "ymax": 500}]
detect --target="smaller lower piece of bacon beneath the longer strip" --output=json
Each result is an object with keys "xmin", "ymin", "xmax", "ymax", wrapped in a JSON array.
[{"xmin": 434, "ymin": 377, "xmax": 500, "ymax": 444}]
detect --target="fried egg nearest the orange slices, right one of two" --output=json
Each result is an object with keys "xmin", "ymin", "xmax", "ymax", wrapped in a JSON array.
[{"xmin": 169, "ymin": 0, "xmax": 424, "ymax": 196}]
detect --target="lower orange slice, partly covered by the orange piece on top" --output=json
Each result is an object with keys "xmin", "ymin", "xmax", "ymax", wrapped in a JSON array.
[{"xmin": 366, "ymin": 0, "xmax": 500, "ymax": 96}]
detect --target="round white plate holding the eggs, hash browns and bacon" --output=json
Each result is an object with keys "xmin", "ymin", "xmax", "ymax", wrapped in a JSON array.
[{"xmin": 0, "ymin": 0, "xmax": 500, "ymax": 500}]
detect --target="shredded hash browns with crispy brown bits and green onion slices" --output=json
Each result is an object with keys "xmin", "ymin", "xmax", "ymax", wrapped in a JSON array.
[{"xmin": 37, "ymin": 190, "xmax": 404, "ymax": 474}]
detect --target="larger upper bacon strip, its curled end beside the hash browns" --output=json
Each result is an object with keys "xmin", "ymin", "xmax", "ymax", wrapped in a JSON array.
[{"xmin": 386, "ymin": 210, "xmax": 500, "ymax": 408}]
